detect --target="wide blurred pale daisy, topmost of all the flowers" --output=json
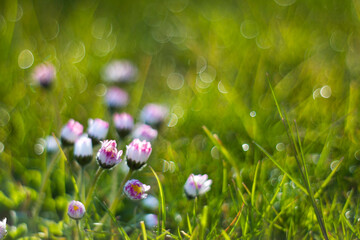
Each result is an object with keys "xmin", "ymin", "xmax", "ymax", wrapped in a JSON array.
[{"xmin": 103, "ymin": 60, "xmax": 137, "ymax": 82}]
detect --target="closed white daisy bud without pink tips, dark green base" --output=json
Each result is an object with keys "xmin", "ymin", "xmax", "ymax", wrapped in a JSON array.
[{"xmin": 74, "ymin": 136, "xmax": 93, "ymax": 166}]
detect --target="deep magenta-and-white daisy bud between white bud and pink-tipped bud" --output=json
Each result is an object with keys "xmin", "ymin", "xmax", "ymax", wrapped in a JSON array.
[{"xmin": 96, "ymin": 140, "xmax": 122, "ymax": 169}]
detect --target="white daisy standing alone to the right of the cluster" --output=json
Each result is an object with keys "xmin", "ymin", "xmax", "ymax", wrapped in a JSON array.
[{"xmin": 184, "ymin": 174, "xmax": 212, "ymax": 199}]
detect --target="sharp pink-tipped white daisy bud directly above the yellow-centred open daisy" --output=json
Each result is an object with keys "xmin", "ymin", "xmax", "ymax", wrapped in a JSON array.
[{"xmin": 126, "ymin": 139, "xmax": 152, "ymax": 170}]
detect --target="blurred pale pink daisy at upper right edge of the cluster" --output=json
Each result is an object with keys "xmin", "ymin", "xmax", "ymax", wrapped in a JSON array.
[{"xmin": 140, "ymin": 103, "xmax": 169, "ymax": 128}]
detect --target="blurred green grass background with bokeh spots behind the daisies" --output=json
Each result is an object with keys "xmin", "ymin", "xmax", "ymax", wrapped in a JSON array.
[{"xmin": 0, "ymin": 0, "xmax": 360, "ymax": 239}]
